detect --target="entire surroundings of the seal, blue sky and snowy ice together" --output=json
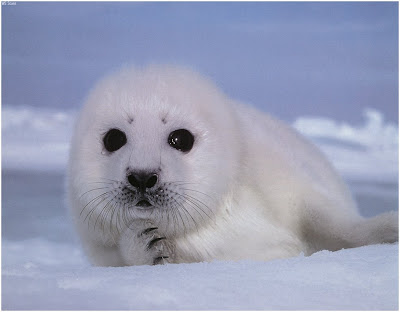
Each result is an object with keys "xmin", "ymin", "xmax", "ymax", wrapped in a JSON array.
[{"xmin": 1, "ymin": 2, "xmax": 399, "ymax": 310}]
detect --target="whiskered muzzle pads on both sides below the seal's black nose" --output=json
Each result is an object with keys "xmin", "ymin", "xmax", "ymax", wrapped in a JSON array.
[{"xmin": 80, "ymin": 178, "xmax": 215, "ymax": 236}]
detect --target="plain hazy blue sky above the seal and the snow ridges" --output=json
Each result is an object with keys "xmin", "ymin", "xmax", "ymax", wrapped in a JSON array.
[{"xmin": 2, "ymin": 2, "xmax": 398, "ymax": 122}]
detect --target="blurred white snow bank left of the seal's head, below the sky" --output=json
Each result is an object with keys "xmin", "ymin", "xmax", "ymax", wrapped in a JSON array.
[{"xmin": 1, "ymin": 105, "xmax": 76, "ymax": 170}]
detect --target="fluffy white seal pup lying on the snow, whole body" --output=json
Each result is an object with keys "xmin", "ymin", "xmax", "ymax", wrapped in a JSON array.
[{"xmin": 68, "ymin": 66, "xmax": 398, "ymax": 266}]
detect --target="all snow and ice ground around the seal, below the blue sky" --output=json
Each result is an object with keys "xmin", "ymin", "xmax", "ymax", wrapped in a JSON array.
[{"xmin": 2, "ymin": 106, "xmax": 399, "ymax": 310}]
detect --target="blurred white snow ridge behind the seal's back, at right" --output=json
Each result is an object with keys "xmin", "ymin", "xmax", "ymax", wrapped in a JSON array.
[{"xmin": 293, "ymin": 109, "xmax": 399, "ymax": 181}]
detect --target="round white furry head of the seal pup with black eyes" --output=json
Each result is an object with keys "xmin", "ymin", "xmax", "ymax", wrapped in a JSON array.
[{"xmin": 69, "ymin": 66, "xmax": 241, "ymax": 237}]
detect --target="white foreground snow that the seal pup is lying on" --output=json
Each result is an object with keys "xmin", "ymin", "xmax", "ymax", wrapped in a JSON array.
[{"xmin": 2, "ymin": 239, "xmax": 399, "ymax": 310}]
